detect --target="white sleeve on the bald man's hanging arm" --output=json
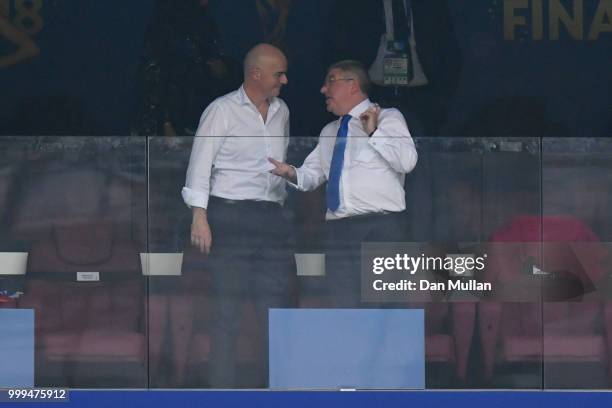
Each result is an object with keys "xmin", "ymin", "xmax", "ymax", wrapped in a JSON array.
[{"xmin": 181, "ymin": 104, "xmax": 227, "ymax": 208}]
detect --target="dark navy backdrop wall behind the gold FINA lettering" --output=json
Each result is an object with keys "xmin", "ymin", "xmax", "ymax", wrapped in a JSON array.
[{"xmin": 0, "ymin": 0, "xmax": 612, "ymax": 137}]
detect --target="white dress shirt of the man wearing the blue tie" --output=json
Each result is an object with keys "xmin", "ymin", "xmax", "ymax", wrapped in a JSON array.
[{"xmin": 293, "ymin": 99, "xmax": 417, "ymax": 220}]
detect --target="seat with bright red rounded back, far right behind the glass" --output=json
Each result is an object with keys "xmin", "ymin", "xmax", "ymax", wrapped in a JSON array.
[{"xmin": 479, "ymin": 215, "xmax": 612, "ymax": 381}]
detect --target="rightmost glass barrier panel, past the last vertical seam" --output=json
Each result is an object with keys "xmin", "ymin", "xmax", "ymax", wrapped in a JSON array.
[{"xmin": 542, "ymin": 139, "xmax": 612, "ymax": 388}]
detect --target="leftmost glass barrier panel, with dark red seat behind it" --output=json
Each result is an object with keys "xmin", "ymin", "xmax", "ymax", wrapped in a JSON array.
[{"xmin": 2, "ymin": 137, "xmax": 146, "ymax": 387}]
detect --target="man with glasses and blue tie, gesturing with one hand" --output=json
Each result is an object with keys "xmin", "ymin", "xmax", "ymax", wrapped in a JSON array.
[{"xmin": 270, "ymin": 60, "xmax": 417, "ymax": 306}]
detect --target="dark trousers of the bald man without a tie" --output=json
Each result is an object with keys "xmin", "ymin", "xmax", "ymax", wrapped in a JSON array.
[{"xmin": 208, "ymin": 197, "xmax": 295, "ymax": 388}]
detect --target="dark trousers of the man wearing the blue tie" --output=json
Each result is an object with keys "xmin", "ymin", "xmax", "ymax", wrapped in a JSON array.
[{"xmin": 325, "ymin": 212, "xmax": 405, "ymax": 308}]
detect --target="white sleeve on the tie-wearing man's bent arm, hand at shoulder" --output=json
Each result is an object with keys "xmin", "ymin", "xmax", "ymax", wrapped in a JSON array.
[{"xmin": 368, "ymin": 109, "xmax": 418, "ymax": 173}]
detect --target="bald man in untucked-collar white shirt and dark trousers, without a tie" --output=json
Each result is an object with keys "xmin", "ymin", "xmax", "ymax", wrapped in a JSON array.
[{"xmin": 182, "ymin": 44, "xmax": 295, "ymax": 388}]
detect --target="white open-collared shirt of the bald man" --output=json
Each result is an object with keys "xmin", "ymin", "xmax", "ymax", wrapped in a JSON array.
[{"xmin": 182, "ymin": 87, "xmax": 289, "ymax": 208}]
